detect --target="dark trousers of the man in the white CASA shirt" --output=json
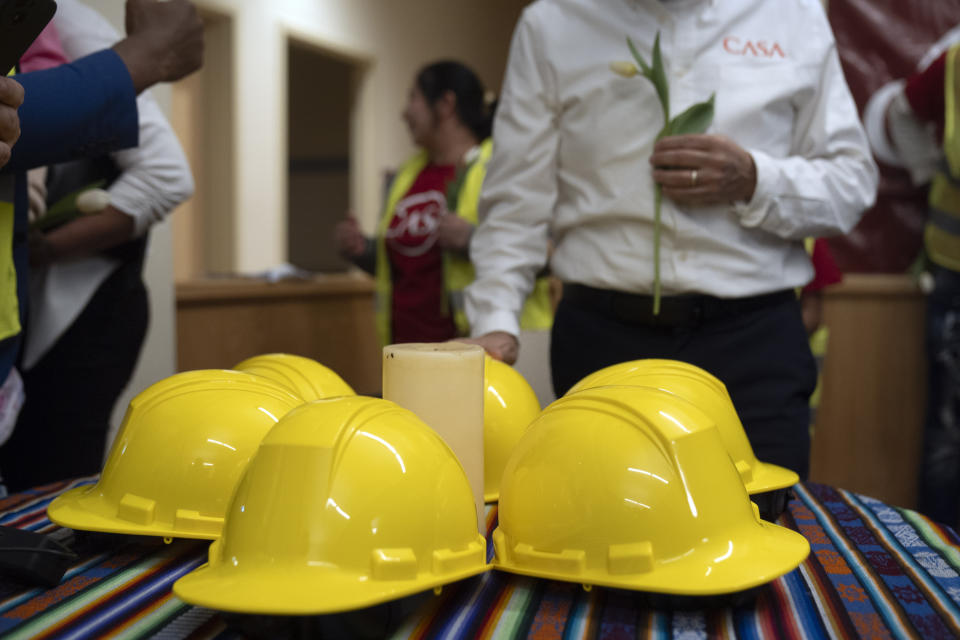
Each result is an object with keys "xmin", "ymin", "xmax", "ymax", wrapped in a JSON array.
[{"xmin": 550, "ymin": 285, "xmax": 817, "ymax": 478}]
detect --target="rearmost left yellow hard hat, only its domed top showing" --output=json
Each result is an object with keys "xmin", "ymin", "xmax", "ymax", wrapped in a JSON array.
[{"xmin": 233, "ymin": 353, "xmax": 357, "ymax": 402}]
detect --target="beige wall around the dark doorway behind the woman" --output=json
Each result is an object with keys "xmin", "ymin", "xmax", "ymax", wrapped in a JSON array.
[{"xmin": 183, "ymin": 0, "xmax": 526, "ymax": 271}]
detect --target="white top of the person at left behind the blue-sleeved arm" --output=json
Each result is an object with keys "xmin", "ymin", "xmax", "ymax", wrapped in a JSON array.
[{"xmin": 23, "ymin": 0, "xmax": 194, "ymax": 369}]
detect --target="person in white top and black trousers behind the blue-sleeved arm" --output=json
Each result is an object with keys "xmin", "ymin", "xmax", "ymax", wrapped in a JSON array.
[{"xmin": 0, "ymin": 0, "xmax": 193, "ymax": 491}]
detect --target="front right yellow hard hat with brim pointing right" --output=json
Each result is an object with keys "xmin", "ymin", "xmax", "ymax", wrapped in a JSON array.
[{"xmin": 493, "ymin": 387, "xmax": 810, "ymax": 595}]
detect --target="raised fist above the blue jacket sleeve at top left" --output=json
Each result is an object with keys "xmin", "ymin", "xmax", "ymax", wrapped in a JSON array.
[{"xmin": 113, "ymin": 0, "xmax": 203, "ymax": 93}]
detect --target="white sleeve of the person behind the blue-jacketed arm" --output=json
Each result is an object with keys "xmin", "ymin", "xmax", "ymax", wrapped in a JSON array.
[{"xmin": 54, "ymin": 0, "xmax": 194, "ymax": 236}]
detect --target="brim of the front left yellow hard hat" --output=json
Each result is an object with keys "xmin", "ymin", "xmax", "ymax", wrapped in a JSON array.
[{"xmin": 173, "ymin": 564, "xmax": 490, "ymax": 615}]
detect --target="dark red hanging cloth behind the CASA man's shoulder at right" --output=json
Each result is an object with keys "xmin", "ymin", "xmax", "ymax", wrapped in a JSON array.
[{"xmin": 824, "ymin": 0, "xmax": 960, "ymax": 273}]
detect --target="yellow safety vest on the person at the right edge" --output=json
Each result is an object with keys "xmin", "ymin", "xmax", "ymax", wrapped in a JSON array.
[{"xmin": 924, "ymin": 45, "xmax": 960, "ymax": 271}]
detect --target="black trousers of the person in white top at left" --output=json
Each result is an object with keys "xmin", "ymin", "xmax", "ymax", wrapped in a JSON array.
[{"xmin": 0, "ymin": 260, "xmax": 149, "ymax": 491}]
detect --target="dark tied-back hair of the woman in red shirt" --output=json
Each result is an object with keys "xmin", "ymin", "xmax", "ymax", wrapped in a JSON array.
[{"xmin": 417, "ymin": 60, "xmax": 493, "ymax": 140}]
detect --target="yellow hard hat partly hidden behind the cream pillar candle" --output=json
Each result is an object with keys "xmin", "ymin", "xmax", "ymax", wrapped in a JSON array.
[{"xmin": 483, "ymin": 356, "xmax": 540, "ymax": 502}]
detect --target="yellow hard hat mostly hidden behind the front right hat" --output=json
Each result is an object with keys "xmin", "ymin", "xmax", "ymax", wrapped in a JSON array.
[{"xmin": 567, "ymin": 359, "xmax": 800, "ymax": 494}]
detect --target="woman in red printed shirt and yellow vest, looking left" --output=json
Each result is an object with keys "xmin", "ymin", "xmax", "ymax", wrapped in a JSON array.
[{"xmin": 336, "ymin": 61, "xmax": 552, "ymax": 345}]
